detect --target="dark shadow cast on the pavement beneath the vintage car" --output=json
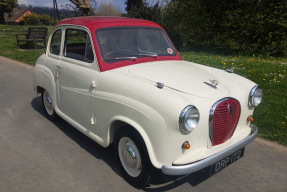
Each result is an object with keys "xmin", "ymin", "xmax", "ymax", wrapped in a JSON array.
[{"xmin": 31, "ymin": 96, "xmax": 214, "ymax": 191}]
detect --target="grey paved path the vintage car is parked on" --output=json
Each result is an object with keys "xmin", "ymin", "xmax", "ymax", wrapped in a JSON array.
[{"xmin": 0, "ymin": 57, "xmax": 287, "ymax": 192}]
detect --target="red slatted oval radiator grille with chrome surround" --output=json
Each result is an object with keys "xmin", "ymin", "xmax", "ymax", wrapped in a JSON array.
[{"xmin": 210, "ymin": 98, "xmax": 241, "ymax": 146}]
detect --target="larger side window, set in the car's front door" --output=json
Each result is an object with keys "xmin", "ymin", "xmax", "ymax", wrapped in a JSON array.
[{"xmin": 64, "ymin": 29, "xmax": 94, "ymax": 63}]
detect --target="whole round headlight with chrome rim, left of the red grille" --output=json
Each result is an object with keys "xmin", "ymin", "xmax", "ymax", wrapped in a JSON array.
[{"xmin": 179, "ymin": 105, "xmax": 199, "ymax": 133}]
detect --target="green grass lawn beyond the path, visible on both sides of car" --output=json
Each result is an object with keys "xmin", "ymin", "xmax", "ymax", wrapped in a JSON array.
[{"xmin": 0, "ymin": 25, "xmax": 287, "ymax": 146}]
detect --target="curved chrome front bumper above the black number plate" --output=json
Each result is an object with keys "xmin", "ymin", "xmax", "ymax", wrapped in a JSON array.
[{"xmin": 162, "ymin": 124, "xmax": 258, "ymax": 175}]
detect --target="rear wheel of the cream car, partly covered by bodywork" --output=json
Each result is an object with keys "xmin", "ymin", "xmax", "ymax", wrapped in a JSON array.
[{"xmin": 42, "ymin": 90, "xmax": 58, "ymax": 121}]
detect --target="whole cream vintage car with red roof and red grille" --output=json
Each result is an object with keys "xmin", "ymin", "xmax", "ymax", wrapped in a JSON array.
[{"xmin": 34, "ymin": 17, "xmax": 262, "ymax": 187}]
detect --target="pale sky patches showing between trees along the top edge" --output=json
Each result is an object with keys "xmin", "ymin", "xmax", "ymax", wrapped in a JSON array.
[{"xmin": 18, "ymin": 0, "xmax": 161, "ymax": 12}]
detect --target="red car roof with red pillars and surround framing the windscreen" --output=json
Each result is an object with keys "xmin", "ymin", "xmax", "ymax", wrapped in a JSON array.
[{"xmin": 56, "ymin": 16, "xmax": 181, "ymax": 72}]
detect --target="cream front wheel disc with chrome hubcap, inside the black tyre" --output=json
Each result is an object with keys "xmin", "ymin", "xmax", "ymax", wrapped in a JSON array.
[{"xmin": 118, "ymin": 137, "xmax": 141, "ymax": 177}]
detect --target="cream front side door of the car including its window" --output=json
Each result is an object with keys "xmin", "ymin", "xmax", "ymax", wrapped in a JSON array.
[{"xmin": 57, "ymin": 27, "xmax": 99, "ymax": 134}]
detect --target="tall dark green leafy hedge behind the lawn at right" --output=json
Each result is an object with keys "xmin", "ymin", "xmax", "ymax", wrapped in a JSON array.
[{"xmin": 160, "ymin": 0, "xmax": 287, "ymax": 56}]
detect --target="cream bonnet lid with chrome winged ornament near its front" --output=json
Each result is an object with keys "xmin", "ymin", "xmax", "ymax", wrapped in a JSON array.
[{"xmin": 128, "ymin": 61, "xmax": 230, "ymax": 98}]
